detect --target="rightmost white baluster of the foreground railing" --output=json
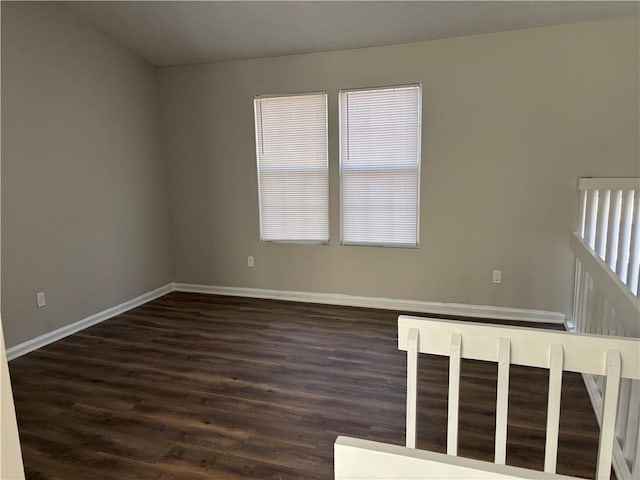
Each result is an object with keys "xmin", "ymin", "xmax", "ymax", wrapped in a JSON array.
[{"xmin": 596, "ymin": 350, "xmax": 621, "ymax": 480}]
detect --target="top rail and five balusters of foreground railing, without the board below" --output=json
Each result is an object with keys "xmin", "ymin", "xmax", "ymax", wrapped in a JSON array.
[{"xmin": 398, "ymin": 315, "xmax": 640, "ymax": 480}]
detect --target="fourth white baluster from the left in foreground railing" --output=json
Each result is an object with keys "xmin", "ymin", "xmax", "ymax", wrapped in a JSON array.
[{"xmin": 544, "ymin": 344, "xmax": 564, "ymax": 473}]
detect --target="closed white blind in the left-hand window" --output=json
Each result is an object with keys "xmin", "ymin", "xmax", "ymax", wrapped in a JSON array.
[{"xmin": 254, "ymin": 93, "xmax": 329, "ymax": 242}]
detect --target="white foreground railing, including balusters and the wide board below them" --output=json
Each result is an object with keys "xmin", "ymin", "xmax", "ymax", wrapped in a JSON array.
[{"xmin": 334, "ymin": 315, "xmax": 640, "ymax": 480}]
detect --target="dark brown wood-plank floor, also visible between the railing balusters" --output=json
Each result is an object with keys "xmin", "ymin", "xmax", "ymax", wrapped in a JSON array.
[{"xmin": 10, "ymin": 293, "xmax": 598, "ymax": 480}]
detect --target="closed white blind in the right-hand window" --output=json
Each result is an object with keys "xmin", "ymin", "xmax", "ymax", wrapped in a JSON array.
[{"xmin": 340, "ymin": 85, "xmax": 422, "ymax": 247}]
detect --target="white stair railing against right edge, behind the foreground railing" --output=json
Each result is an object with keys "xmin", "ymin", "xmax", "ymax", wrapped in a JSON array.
[{"xmin": 571, "ymin": 178, "xmax": 640, "ymax": 480}]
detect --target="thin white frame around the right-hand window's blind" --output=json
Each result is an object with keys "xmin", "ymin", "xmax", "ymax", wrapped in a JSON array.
[{"xmin": 338, "ymin": 83, "xmax": 423, "ymax": 249}]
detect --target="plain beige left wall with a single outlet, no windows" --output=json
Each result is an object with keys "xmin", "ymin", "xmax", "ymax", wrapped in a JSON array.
[{"xmin": 2, "ymin": 2, "xmax": 173, "ymax": 347}]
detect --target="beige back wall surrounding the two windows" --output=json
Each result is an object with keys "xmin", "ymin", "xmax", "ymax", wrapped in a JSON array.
[{"xmin": 160, "ymin": 19, "xmax": 640, "ymax": 313}]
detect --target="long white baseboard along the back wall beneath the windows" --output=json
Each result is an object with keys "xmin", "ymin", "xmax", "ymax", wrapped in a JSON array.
[{"xmin": 175, "ymin": 283, "xmax": 565, "ymax": 324}]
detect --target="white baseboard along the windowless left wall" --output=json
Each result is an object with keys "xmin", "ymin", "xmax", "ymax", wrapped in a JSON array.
[{"xmin": 7, "ymin": 283, "xmax": 175, "ymax": 360}]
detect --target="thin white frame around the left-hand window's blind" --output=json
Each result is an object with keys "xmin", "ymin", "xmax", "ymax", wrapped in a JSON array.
[{"xmin": 253, "ymin": 90, "xmax": 331, "ymax": 245}]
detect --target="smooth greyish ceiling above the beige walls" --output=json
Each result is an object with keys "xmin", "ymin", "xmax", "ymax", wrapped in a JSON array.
[{"xmin": 62, "ymin": 1, "xmax": 640, "ymax": 66}]
